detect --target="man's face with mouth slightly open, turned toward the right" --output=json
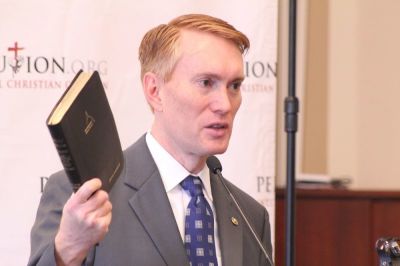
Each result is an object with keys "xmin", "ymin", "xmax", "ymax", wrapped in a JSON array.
[{"xmin": 153, "ymin": 30, "xmax": 244, "ymax": 160}]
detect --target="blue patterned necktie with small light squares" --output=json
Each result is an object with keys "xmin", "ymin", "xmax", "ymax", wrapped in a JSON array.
[{"xmin": 181, "ymin": 175, "xmax": 218, "ymax": 266}]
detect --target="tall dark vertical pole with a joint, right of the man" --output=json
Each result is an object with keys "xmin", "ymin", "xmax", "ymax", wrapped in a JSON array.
[{"xmin": 285, "ymin": 0, "xmax": 299, "ymax": 266}]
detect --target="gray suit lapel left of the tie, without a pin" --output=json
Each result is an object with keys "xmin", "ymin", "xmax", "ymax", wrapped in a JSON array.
[{"xmin": 125, "ymin": 137, "xmax": 189, "ymax": 265}]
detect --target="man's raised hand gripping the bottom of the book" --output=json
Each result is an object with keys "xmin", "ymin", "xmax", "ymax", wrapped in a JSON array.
[{"xmin": 55, "ymin": 178, "xmax": 112, "ymax": 265}]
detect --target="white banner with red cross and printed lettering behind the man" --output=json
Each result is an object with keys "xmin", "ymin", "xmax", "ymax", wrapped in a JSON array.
[{"xmin": 0, "ymin": 0, "xmax": 278, "ymax": 266}]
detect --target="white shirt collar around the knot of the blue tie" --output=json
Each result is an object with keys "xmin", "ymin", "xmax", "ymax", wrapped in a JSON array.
[{"xmin": 146, "ymin": 132, "xmax": 212, "ymax": 199}]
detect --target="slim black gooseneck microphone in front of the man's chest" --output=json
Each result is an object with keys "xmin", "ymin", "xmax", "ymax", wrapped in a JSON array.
[{"xmin": 206, "ymin": 155, "xmax": 274, "ymax": 265}]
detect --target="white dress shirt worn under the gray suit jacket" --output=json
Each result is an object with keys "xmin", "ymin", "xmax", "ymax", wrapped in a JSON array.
[{"xmin": 146, "ymin": 132, "xmax": 222, "ymax": 265}]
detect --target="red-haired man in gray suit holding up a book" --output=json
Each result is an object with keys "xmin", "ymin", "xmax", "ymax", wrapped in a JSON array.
[{"xmin": 28, "ymin": 14, "xmax": 272, "ymax": 266}]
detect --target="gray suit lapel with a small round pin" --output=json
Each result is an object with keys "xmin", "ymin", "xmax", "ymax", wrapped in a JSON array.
[{"xmin": 210, "ymin": 174, "xmax": 244, "ymax": 266}]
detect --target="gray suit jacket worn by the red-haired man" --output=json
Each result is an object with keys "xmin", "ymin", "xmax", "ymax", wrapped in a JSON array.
[{"xmin": 28, "ymin": 136, "xmax": 272, "ymax": 266}]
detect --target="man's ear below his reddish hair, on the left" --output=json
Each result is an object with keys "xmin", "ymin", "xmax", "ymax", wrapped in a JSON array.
[{"xmin": 143, "ymin": 72, "xmax": 163, "ymax": 112}]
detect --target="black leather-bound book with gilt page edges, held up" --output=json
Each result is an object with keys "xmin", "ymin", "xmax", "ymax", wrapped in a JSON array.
[{"xmin": 47, "ymin": 70, "xmax": 124, "ymax": 192}]
